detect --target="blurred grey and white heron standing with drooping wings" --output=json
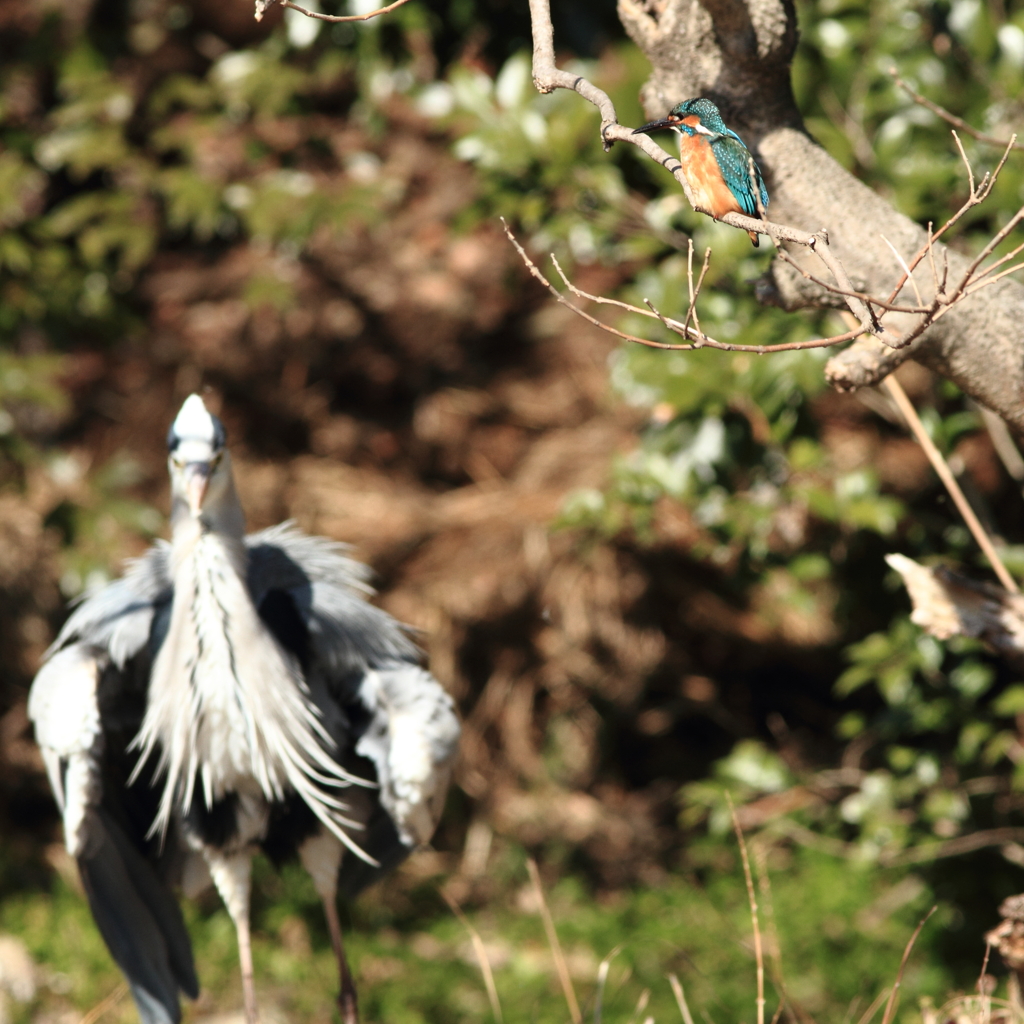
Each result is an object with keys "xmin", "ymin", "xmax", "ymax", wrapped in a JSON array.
[{"xmin": 29, "ymin": 394, "xmax": 460, "ymax": 1024}]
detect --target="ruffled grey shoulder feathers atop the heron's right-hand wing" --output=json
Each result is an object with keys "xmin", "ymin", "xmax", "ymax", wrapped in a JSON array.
[{"xmin": 246, "ymin": 522, "xmax": 419, "ymax": 680}]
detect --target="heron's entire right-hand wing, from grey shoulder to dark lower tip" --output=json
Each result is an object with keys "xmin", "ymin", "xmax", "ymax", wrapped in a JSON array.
[{"xmin": 247, "ymin": 523, "xmax": 460, "ymax": 895}]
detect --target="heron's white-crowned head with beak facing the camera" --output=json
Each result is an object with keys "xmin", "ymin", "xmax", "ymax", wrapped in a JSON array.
[{"xmin": 167, "ymin": 394, "xmax": 237, "ymax": 519}]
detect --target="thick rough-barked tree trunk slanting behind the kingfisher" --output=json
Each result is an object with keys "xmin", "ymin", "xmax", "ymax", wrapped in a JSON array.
[{"xmin": 618, "ymin": 0, "xmax": 1024, "ymax": 435}]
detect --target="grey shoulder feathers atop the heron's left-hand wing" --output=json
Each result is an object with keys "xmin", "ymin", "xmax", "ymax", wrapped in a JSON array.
[{"xmin": 50, "ymin": 541, "xmax": 171, "ymax": 669}]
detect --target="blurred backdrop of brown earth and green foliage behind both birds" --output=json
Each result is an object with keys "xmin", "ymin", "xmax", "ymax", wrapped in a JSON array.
[{"xmin": 0, "ymin": 0, "xmax": 1024, "ymax": 1024}]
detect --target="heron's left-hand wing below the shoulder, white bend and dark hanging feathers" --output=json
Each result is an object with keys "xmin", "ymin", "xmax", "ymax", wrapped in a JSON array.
[{"xmin": 29, "ymin": 643, "xmax": 199, "ymax": 1024}]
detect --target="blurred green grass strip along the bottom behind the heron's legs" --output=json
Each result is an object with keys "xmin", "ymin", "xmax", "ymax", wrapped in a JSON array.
[{"xmin": 0, "ymin": 831, "xmax": 983, "ymax": 1024}]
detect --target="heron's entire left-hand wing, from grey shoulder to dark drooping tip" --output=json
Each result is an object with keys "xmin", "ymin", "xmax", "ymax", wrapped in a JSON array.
[{"xmin": 29, "ymin": 569, "xmax": 199, "ymax": 1024}]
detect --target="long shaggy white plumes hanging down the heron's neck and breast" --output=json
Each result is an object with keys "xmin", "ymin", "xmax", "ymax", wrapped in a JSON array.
[{"xmin": 132, "ymin": 519, "xmax": 374, "ymax": 863}]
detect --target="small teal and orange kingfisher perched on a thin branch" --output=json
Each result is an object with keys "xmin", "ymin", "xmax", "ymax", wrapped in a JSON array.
[{"xmin": 633, "ymin": 97, "xmax": 768, "ymax": 246}]
